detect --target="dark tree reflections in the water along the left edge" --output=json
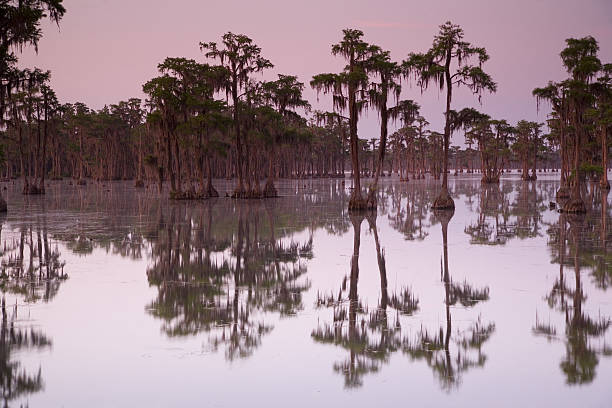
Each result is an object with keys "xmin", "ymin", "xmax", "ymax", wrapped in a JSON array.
[{"xmin": 0, "ymin": 217, "xmax": 68, "ymax": 407}]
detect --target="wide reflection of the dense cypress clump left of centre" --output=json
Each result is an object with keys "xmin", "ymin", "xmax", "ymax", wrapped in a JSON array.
[{"xmin": 147, "ymin": 202, "xmax": 312, "ymax": 360}]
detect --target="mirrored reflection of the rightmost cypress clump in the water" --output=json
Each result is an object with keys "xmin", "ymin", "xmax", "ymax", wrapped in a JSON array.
[{"xmin": 533, "ymin": 186, "xmax": 612, "ymax": 385}]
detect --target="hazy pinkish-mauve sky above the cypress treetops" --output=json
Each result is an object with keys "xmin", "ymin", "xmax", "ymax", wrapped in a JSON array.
[{"xmin": 19, "ymin": 0, "xmax": 612, "ymax": 144}]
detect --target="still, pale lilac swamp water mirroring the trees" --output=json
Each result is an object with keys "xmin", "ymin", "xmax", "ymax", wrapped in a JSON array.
[{"xmin": 0, "ymin": 175, "xmax": 612, "ymax": 407}]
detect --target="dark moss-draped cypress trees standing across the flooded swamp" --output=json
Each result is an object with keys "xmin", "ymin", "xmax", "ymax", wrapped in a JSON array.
[{"xmin": 0, "ymin": 0, "xmax": 612, "ymax": 213}]
